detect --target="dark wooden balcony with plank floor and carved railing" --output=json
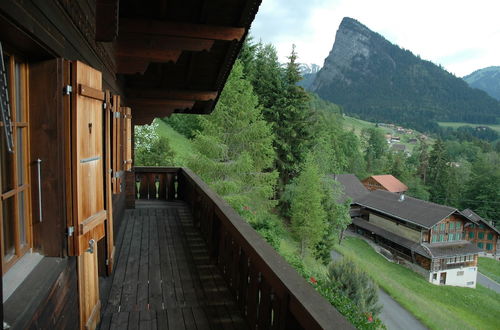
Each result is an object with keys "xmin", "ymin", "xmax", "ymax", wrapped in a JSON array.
[{"xmin": 101, "ymin": 168, "xmax": 353, "ymax": 329}]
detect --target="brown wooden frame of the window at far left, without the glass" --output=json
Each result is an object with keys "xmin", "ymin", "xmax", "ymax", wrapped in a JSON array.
[{"xmin": 0, "ymin": 52, "xmax": 32, "ymax": 274}]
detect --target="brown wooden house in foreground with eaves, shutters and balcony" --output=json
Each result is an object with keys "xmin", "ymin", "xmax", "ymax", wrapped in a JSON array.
[{"xmin": 0, "ymin": 0, "xmax": 350, "ymax": 329}]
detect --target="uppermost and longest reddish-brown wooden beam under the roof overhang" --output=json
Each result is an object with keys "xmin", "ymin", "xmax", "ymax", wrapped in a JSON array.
[{"xmin": 120, "ymin": 18, "xmax": 245, "ymax": 41}]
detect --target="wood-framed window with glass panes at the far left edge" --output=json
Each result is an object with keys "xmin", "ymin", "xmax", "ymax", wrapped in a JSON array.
[{"xmin": 0, "ymin": 55, "xmax": 31, "ymax": 273}]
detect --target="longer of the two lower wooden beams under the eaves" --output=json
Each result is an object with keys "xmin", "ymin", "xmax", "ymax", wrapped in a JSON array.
[{"xmin": 126, "ymin": 89, "xmax": 218, "ymax": 101}]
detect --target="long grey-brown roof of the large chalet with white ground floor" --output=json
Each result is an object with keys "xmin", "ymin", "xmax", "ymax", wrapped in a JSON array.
[{"xmin": 355, "ymin": 190, "xmax": 458, "ymax": 229}]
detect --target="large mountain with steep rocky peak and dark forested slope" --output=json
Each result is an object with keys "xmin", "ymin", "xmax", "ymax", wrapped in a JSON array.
[{"xmin": 309, "ymin": 17, "xmax": 500, "ymax": 131}]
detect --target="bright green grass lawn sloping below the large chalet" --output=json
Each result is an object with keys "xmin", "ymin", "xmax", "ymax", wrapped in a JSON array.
[{"xmin": 336, "ymin": 237, "xmax": 500, "ymax": 329}]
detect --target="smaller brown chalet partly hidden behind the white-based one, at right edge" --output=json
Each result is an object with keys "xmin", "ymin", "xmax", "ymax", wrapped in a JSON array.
[{"xmin": 461, "ymin": 209, "xmax": 500, "ymax": 258}]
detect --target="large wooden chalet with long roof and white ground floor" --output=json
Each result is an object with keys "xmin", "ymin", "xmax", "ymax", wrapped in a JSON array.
[{"xmin": 352, "ymin": 190, "xmax": 481, "ymax": 288}]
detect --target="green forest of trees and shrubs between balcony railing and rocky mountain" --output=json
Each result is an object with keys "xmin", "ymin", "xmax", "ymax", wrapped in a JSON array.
[{"xmin": 135, "ymin": 39, "xmax": 500, "ymax": 329}]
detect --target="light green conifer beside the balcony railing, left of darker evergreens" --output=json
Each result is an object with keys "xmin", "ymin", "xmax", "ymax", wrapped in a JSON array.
[{"xmin": 189, "ymin": 61, "xmax": 277, "ymax": 212}]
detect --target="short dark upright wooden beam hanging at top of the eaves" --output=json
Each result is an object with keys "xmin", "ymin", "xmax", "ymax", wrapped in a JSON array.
[{"xmin": 95, "ymin": 0, "xmax": 119, "ymax": 41}]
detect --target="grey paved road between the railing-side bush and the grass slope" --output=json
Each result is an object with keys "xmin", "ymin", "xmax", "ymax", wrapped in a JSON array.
[{"xmin": 331, "ymin": 251, "xmax": 427, "ymax": 330}]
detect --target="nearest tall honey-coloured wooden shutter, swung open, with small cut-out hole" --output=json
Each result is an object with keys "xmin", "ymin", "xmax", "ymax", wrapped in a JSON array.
[{"xmin": 71, "ymin": 61, "xmax": 107, "ymax": 329}]
